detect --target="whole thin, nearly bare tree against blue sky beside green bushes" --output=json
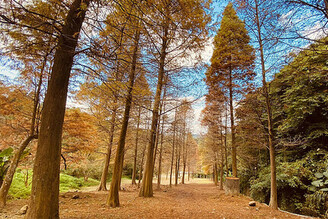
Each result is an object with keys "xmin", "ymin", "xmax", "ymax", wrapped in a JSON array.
[{"xmin": 239, "ymin": 0, "xmax": 283, "ymax": 209}]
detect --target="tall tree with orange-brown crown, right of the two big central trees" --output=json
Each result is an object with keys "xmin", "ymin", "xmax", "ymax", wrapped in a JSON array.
[{"xmin": 139, "ymin": 0, "xmax": 210, "ymax": 197}]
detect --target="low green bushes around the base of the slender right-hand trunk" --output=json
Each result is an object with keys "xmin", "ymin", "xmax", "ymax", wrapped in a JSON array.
[{"xmin": 250, "ymin": 151, "xmax": 328, "ymax": 213}]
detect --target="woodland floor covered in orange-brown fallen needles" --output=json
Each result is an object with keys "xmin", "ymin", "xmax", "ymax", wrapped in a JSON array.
[{"xmin": 0, "ymin": 180, "xmax": 318, "ymax": 219}]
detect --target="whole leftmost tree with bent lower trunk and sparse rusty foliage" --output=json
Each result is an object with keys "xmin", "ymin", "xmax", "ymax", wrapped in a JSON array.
[{"xmin": 0, "ymin": 2, "xmax": 62, "ymax": 206}]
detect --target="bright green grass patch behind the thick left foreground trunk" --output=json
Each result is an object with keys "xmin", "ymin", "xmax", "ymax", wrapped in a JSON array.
[{"xmin": 8, "ymin": 170, "xmax": 99, "ymax": 199}]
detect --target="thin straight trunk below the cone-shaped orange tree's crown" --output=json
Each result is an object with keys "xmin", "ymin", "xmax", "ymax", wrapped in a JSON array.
[{"xmin": 229, "ymin": 67, "xmax": 237, "ymax": 177}]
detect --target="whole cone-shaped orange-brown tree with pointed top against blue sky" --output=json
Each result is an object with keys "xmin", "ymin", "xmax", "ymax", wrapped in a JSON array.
[{"xmin": 206, "ymin": 3, "xmax": 255, "ymax": 177}]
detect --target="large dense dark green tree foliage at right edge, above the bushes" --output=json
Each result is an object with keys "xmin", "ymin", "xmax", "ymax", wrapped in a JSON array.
[{"xmin": 271, "ymin": 39, "xmax": 328, "ymax": 155}]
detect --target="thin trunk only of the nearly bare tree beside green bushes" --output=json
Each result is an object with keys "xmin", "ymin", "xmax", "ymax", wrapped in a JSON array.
[{"xmin": 255, "ymin": 0, "xmax": 278, "ymax": 210}]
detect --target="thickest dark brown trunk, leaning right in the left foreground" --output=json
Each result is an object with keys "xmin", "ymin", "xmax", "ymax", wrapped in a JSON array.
[{"xmin": 26, "ymin": 0, "xmax": 90, "ymax": 219}]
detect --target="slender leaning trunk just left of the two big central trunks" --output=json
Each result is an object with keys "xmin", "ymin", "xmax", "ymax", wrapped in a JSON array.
[{"xmin": 97, "ymin": 103, "xmax": 117, "ymax": 191}]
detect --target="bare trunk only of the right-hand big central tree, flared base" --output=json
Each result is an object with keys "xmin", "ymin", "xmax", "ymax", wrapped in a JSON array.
[{"xmin": 139, "ymin": 17, "xmax": 169, "ymax": 197}]
